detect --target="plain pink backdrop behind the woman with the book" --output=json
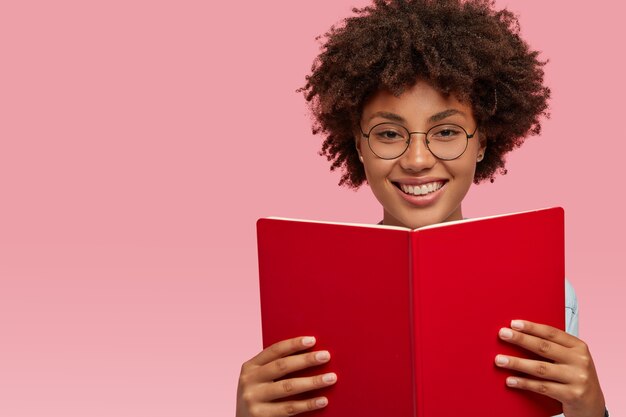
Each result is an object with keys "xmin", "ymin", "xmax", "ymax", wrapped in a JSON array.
[{"xmin": 0, "ymin": 0, "xmax": 626, "ymax": 417}]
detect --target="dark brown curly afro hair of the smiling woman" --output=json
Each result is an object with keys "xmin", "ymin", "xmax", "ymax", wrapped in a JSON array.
[{"xmin": 298, "ymin": 0, "xmax": 550, "ymax": 188}]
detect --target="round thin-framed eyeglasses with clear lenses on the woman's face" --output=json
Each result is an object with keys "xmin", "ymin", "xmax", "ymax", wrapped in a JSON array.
[{"xmin": 361, "ymin": 123, "xmax": 478, "ymax": 161}]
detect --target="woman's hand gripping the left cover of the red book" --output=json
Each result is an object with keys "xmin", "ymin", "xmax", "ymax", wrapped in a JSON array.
[{"xmin": 236, "ymin": 336, "xmax": 337, "ymax": 417}]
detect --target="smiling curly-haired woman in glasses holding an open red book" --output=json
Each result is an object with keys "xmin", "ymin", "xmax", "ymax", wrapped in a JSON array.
[{"xmin": 237, "ymin": 0, "xmax": 607, "ymax": 417}]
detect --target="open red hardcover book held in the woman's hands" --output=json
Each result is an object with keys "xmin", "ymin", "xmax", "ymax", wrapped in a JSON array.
[{"xmin": 257, "ymin": 208, "xmax": 565, "ymax": 417}]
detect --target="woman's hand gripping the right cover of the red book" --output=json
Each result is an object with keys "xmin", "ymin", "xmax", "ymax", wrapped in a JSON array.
[{"xmin": 495, "ymin": 320, "xmax": 605, "ymax": 417}]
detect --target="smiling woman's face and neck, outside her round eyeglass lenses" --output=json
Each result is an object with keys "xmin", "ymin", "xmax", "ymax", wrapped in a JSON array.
[{"xmin": 355, "ymin": 81, "xmax": 485, "ymax": 229}]
